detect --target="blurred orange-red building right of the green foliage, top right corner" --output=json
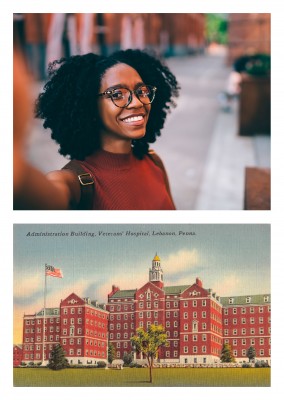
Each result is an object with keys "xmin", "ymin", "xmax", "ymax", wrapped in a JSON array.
[{"xmin": 227, "ymin": 13, "xmax": 271, "ymax": 65}]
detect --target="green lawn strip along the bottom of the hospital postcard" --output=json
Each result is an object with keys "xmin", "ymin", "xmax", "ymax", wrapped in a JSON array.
[{"xmin": 14, "ymin": 368, "xmax": 270, "ymax": 387}]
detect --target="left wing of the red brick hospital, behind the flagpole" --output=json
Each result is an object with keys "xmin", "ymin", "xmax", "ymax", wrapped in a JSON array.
[{"xmin": 22, "ymin": 293, "xmax": 108, "ymax": 364}]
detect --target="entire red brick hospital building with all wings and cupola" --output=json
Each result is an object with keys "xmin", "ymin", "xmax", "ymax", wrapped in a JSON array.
[{"xmin": 17, "ymin": 255, "xmax": 271, "ymax": 365}]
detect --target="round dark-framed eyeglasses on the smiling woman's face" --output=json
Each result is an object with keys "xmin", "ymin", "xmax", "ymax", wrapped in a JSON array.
[{"xmin": 98, "ymin": 85, "xmax": 157, "ymax": 108}]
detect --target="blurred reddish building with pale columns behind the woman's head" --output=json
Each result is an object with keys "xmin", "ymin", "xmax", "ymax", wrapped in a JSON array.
[{"xmin": 14, "ymin": 13, "xmax": 206, "ymax": 80}]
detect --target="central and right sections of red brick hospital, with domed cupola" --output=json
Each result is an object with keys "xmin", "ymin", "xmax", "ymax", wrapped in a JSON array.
[{"xmin": 107, "ymin": 255, "xmax": 270, "ymax": 364}]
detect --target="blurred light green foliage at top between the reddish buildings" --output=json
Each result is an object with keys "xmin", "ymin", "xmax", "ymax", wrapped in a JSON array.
[{"xmin": 206, "ymin": 14, "xmax": 228, "ymax": 44}]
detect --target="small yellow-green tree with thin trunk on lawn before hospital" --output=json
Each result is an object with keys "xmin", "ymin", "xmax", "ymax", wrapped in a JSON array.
[{"xmin": 131, "ymin": 325, "xmax": 169, "ymax": 383}]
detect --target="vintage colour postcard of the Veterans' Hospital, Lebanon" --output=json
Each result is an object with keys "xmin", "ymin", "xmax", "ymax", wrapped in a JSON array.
[{"xmin": 13, "ymin": 224, "xmax": 271, "ymax": 387}]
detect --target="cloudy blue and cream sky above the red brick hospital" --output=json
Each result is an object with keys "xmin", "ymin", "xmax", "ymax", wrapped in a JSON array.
[{"xmin": 13, "ymin": 224, "xmax": 270, "ymax": 343}]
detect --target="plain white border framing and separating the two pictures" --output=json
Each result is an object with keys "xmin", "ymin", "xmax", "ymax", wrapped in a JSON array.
[{"xmin": 0, "ymin": 0, "xmax": 284, "ymax": 400}]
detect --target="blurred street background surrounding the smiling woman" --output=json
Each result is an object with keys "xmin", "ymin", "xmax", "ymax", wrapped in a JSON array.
[{"xmin": 14, "ymin": 13, "xmax": 271, "ymax": 210}]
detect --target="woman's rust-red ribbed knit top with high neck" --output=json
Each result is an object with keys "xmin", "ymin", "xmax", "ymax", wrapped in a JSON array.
[{"xmin": 80, "ymin": 150, "xmax": 175, "ymax": 210}]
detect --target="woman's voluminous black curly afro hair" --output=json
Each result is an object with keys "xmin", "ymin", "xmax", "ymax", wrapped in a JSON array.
[{"xmin": 35, "ymin": 49, "xmax": 180, "ymax": 160}]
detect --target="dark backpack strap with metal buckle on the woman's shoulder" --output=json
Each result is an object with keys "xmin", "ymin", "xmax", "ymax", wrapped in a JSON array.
[{"xmin": 62, "ymin": 160, "xmax": 95, "ymax": 210}]
